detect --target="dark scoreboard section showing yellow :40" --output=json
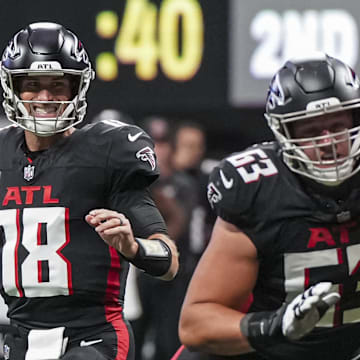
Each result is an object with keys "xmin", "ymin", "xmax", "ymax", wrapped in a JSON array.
[{"xmin": 89, "ymin": 0, "xmax": 227, "ymax": 111}]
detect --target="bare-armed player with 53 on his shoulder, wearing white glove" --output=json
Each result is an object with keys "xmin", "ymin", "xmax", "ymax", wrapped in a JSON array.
[{"xmin": 173, "ymin": 54, "xmax": 360, "ymax": 360}]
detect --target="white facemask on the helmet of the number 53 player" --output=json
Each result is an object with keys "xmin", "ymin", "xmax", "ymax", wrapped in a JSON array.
[{"xmin": 265, "ymin": 101, "xmax": 360, "ymax": 186}]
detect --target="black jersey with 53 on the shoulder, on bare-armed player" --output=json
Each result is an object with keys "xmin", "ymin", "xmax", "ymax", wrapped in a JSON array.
[{"xmin": 208, "ymin": 143, "xmax": 360, "ymax": 360}]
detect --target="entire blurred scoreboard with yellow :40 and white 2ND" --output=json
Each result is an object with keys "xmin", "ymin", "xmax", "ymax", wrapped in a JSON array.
[{"xmin": 0, "ymin": 0, "xmax": 360, "ymax": 118}]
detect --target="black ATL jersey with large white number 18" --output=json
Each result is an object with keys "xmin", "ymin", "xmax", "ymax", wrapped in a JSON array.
[{"xmin": 0, "ymin": 121, "xmax": 166, "ymax": 328}]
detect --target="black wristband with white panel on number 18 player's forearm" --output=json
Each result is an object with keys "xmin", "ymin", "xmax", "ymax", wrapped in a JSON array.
[{"xmin": 126, "ymin": 238, "xmax": 172, "ymax": 276}]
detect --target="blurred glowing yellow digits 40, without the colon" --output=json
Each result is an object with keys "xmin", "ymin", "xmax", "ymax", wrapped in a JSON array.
[{"xmin": 115, "ymin": 0, "xmax": 204, "ymax": 80}]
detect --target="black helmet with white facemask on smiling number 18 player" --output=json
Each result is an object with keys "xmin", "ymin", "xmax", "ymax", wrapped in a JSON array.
[{"xmin": 0, "ymin": 22, "xmax": 95, "ymax": 136}]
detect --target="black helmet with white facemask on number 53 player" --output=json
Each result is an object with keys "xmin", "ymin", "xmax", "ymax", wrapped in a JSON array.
[{"xmin": 265, "ymin": 53, "xmax": 360, "ymax": 185}]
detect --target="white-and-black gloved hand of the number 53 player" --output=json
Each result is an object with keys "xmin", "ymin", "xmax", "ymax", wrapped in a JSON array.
[{"xmin": 282, "ymin": 282, "xmax": 340, "ymax": 340}]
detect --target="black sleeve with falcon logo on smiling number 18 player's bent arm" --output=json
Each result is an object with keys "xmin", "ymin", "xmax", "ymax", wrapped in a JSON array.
[{"xmin": 102, "ymin": 121, "xmax": 167, "ymax": 238}]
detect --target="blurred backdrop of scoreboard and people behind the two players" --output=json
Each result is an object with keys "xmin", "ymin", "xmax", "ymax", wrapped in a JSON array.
[{"xmin": 0, "ymin": 0, "xmax": 360, "ymax": 360}]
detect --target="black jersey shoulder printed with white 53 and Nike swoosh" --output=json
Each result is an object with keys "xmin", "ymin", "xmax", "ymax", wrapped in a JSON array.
[{"xmin": 208, "ymin": 145, "xmax": 278, "ymax": 223}]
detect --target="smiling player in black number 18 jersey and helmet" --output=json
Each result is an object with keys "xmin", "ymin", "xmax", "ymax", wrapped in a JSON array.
[{"xmin": 0, "ymin": 23, "xmax": 178, "ymax": 360}]
